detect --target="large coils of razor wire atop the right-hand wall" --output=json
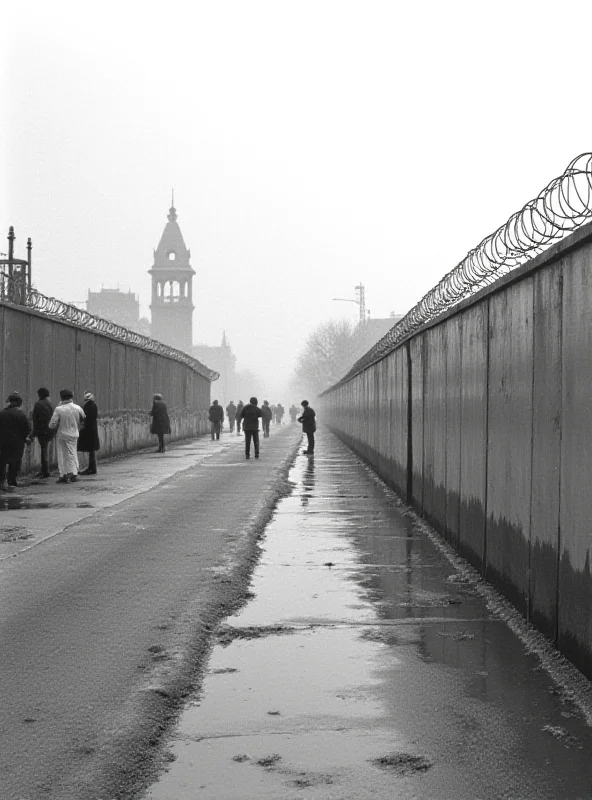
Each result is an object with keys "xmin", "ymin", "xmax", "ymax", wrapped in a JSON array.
[{"xmin": 321, "ymin": 153, "xmax": 592, "ymax": 396}]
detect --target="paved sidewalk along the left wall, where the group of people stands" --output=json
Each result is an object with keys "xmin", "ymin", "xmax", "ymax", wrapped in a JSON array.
[{"xmin": 0, "ymin": 426, "xmax": 286, "ymax": 561}]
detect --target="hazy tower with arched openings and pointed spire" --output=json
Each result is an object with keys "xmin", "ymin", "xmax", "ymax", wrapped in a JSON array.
[{"xmin": 149, "ymin": 195, "xmax": 195, "ymax": 353}]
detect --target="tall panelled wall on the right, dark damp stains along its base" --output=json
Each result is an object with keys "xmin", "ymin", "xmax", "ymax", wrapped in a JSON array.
[{"xmin": 320, "ymin": 225, "xmax": 592, "ymax": 677}]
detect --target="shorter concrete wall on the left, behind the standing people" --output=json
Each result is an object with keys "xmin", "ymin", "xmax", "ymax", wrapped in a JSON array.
[{"xmin": 0, "ymin": 303, "xmax": 210, "ymax": 472}]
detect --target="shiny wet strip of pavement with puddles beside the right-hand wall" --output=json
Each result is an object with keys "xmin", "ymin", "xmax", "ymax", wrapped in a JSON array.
[{"xmin": 145, "ymin": 432, "xmax": 592, "ymax": 800}]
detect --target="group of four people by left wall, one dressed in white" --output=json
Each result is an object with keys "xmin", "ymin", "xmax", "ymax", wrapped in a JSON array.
[{"xmin": 0, "ymin": 387, "xmax": 100, "ymax": 491}]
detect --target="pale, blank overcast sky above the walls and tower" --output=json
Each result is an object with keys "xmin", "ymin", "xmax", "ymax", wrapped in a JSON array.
[{"xmin": 0, "ymin": 0, "xmax": 592, "ymax": 394}]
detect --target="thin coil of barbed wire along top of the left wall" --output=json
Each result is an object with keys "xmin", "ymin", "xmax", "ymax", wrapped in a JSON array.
[{"xmin": 0, "ymin": 275, "xmax": 220, "ymax": 382}]
